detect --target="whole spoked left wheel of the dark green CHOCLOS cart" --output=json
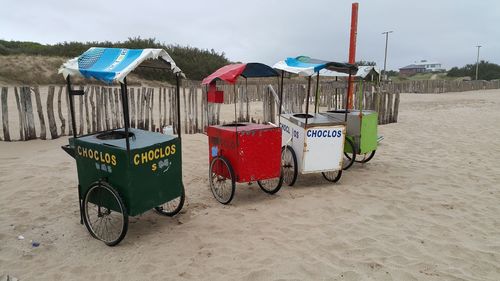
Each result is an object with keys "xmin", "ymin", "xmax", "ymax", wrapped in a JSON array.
[{"xmin": 83, "ymin": 182, "xmax": 128, "ymax": 246}]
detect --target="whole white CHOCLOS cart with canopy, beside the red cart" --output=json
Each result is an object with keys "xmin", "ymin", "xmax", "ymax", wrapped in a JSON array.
[{"xmin": 274, "ymin": 56, "xmax": 357, "ymax": 186}]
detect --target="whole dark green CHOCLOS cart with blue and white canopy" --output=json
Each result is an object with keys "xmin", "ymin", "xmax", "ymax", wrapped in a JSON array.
[{"xmin": 59, "ymin": 48, "xmax": 185, "ymax": 246}]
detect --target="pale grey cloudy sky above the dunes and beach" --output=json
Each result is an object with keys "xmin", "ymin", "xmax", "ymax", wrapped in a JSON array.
[{"xmin": 0, "ymin": 0, "xmax": 500, "ymax": 69}]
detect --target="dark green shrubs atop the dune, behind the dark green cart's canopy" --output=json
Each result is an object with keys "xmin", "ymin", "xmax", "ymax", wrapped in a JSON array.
[{"xmin": 0, "ymin": 37, "xmax": 230, "ymax": 81}]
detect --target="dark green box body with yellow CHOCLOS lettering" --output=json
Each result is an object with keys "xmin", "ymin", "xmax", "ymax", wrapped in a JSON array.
[{"xmin": 70, "ymin": 129, "xmax": 182, "ymax": 216}]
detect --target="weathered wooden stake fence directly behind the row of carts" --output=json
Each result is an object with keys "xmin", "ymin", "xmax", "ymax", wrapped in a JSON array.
[{"xmin": 0, "ymin": 81, "xmax": 399, "ymax": 141}]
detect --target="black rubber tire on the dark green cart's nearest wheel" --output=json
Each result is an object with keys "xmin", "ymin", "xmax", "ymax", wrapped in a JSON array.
[{"xmin": 82, "ymin": 181, "xmax": 128, "ymax": 246}]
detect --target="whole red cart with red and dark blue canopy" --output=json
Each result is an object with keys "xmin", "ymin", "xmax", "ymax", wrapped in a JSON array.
[{"xmin": 202, "ymin": 63, "xmax": 283, "ymax": 204}]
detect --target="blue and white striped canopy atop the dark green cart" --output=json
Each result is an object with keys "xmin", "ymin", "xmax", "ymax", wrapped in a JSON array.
[{"xmin": 59, "ymin": 47, "xmax": 182, "ymax": 83}]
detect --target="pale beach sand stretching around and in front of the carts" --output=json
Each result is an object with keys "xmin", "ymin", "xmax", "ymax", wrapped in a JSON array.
[{"xmin": 0, "ymin": 90, "xmax": 500, "ymax": 280}]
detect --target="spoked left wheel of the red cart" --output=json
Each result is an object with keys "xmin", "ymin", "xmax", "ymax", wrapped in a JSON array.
[{"xmin": 208, "ymin": 156, "xmax": 236, "ymax": 204}]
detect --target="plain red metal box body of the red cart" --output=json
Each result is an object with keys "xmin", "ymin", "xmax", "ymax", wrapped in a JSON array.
[{"xmin": 207, "ymin": 123, "xmax": 281, "ymax": 182}]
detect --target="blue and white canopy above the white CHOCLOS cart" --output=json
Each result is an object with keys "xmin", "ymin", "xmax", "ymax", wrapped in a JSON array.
[{"xmin": 273, "ymin": 56, "xmax": 357, "ymax": 76}]
